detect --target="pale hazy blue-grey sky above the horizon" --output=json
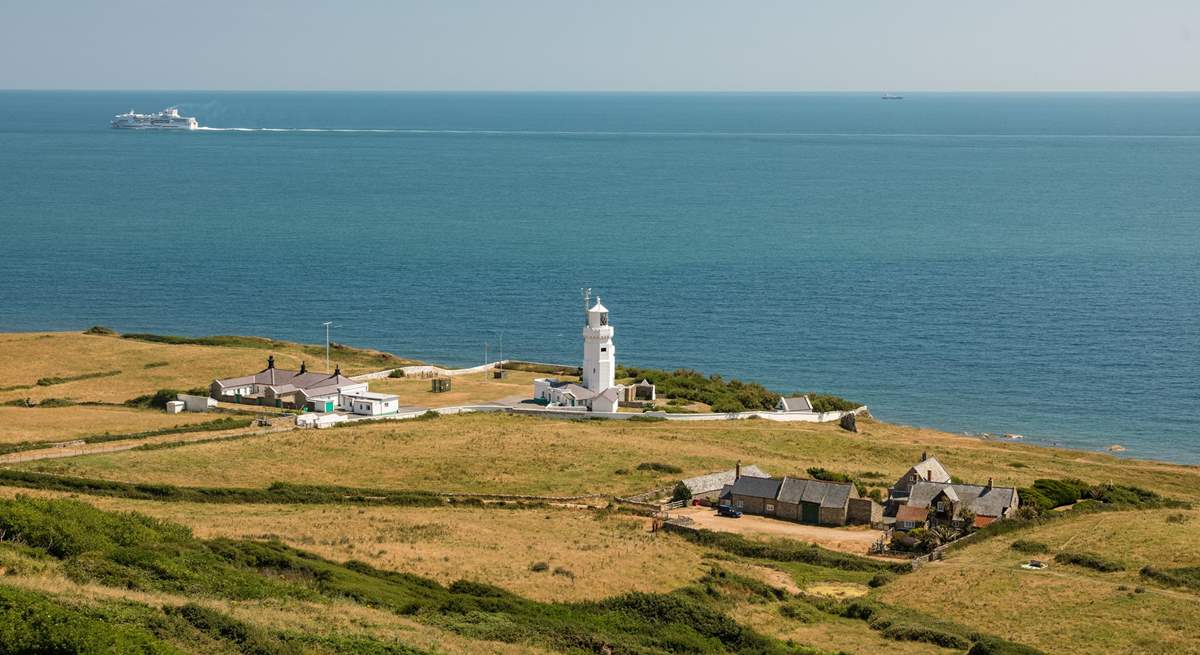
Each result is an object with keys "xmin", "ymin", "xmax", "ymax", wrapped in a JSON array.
[{"xmin": 0, "ymin": 0, "xmax": 1200, "ymax": 91}]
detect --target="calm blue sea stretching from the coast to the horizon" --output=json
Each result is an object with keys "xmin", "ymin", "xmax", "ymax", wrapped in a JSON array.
[{"xmin": 0, "ymin": 91, "xmax": 1200, "ymax": 463}]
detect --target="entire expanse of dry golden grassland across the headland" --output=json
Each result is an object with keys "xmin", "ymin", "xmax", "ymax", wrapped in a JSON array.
[{"xmin": 0, "ymin": 333, "xmax": 1200, "ymax": 655}]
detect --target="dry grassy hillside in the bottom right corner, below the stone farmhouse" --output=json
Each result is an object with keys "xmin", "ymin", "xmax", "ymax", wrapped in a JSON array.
[{"xmin": 881, "ymin": 510, "xmax": 1200, "ymax": 655}]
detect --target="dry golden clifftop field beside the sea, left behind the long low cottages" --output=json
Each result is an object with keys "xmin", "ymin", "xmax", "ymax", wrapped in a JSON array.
[{"xmin": 0, "ymin": 332, "xmax": 403, "ymax": 402}]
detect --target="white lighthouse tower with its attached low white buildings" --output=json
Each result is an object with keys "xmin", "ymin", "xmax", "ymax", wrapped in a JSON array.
[{"xmin": 533, "ymin": 296, "xmax": 655, "ymax": 411}]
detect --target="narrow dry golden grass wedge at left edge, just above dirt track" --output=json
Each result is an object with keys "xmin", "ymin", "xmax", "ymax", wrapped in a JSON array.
[{"xmin": 0, "ymin": 405, "xmax": 217, "ymax": 444}]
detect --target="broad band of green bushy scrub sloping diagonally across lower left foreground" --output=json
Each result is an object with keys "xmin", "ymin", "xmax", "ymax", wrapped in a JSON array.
[{"xmin": 0, "ymin": 498, "xmax": 811, "ymax": 655}]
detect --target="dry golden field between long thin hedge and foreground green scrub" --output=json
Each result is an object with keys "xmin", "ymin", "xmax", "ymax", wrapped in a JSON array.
[{"xmin": 0, "ymin": 487, "xmax": 702, "ymax": 601}]
